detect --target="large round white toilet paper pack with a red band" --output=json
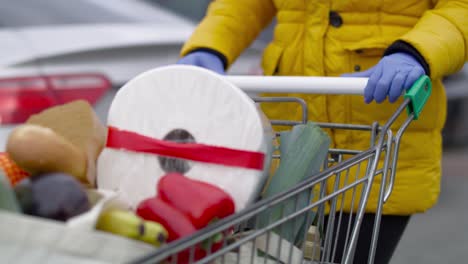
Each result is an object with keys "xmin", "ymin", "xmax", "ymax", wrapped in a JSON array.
[{"xmin": 97, "ymin": 65, "xmax": 273, "ymax": 211}]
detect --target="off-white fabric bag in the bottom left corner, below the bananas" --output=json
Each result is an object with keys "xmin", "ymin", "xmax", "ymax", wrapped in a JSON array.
[{"xmin": 0, "ymin": 210, "xmax": 155, "ymax": 264}]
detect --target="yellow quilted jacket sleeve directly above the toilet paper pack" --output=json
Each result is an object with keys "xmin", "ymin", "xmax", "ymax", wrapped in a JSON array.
[{"xmin": 181, "ymin": 0, "xmax": 276, "ymax": 67}]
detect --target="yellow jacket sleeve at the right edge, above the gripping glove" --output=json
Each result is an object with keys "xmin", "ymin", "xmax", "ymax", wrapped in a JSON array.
[{"xmin": 400, "ymin": 0, "xmax": 468, "ymax": 79}]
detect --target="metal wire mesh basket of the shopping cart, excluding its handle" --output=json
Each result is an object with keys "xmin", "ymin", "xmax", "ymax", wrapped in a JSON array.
[{"xmin": 134, "ymin": 97, "xmax": 414, "ymax": 264}]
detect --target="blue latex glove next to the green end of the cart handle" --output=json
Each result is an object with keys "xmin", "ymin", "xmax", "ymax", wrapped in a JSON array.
[{"xmin": 343, "ymin": 53, "xmax": 425, "ymax": 103}]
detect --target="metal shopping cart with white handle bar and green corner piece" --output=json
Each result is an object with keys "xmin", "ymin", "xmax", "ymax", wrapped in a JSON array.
[{"xmin": 131, "ymin": 76, "xmax": 431, "ymax": 263}]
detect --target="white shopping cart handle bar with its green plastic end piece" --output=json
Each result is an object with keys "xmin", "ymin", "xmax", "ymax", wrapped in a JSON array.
[{"xmin": 226, "ymin": 75, "xmax": 432, "ymax": 119}]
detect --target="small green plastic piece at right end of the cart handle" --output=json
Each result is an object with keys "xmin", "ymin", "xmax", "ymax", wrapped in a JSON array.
[{"xmin": 405, "ymin": 75, "xmax": 432, "ymax": 120}]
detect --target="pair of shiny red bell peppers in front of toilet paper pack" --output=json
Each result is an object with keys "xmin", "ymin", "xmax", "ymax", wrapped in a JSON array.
[{"xmin": 136, "ymin": 173, "xmax": 235, "ymax": 263}]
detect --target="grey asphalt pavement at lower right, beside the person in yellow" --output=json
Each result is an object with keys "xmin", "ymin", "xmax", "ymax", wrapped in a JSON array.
[{"xmin": 391, "ymin": 148, "xmax": 468, "ymax": 264}]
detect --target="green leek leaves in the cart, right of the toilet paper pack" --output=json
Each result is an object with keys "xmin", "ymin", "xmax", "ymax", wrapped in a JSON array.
[{"xmin": 259, "ymin": 122, "xmax": 331, "ymax": 245}]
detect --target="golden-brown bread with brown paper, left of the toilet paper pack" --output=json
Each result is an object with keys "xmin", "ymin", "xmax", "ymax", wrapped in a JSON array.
[{"xmin": 7, "ymin": 100, "xmax": 106, "ymax": 187}]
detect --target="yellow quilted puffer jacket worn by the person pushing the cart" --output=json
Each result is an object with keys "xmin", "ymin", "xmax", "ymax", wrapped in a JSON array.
[{"xmin": 181, "ymin": 0, "xmax": 468, "ymax": 214}]
